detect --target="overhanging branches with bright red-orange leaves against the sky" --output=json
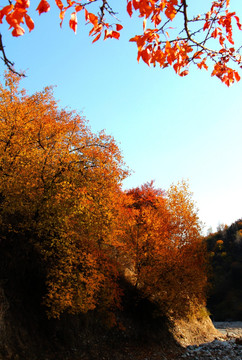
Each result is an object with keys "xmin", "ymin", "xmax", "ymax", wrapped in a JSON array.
[{"xmin": 0, "ymin": 0, "xmax": 242, "ymax": 86}]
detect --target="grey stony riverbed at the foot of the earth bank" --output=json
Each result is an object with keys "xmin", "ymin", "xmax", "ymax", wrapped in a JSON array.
[{"xmin": 177, "ymin": 322, "xmax": 242, "ymax": 360}]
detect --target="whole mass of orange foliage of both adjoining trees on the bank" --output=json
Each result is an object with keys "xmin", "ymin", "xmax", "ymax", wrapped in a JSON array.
[{"xmin": 0, "ymin": 73, "xmax": 206, "ymax": 317}]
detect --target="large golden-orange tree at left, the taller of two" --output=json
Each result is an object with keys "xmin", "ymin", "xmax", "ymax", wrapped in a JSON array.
[{"xmin": 0, "ymin": 73, "xmax": 127, "ymax": 317}]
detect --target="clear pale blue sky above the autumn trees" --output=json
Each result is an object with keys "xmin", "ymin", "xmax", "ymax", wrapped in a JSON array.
[{"xmin": 0, "ymin": 0, "xmax": 242, "ymax": 230}]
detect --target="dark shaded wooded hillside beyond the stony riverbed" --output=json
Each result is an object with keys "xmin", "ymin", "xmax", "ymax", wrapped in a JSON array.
[{"xmin": 205, "ymin": 219, "xmax": 242, "ymax": 321}]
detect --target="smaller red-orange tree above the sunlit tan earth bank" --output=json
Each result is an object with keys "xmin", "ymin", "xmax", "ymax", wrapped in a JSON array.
[{"xmin": 118, "ymin": 182, "xmax": 207, "ymax": 316}]
